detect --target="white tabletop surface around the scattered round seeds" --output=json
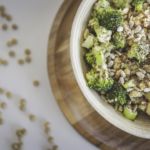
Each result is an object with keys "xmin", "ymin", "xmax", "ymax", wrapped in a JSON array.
[{"xmin": 0, "ymin": 0, "xmax": 97, "ymax": 150}]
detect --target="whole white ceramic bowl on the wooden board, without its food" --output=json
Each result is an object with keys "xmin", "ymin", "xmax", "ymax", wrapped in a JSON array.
[{"xmin": 70, "ymin": 0, "xmax": 150, "ymax": 139}]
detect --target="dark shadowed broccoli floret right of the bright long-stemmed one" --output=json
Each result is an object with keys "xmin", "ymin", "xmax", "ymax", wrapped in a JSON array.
[{"xmin": 107, "ymin": 83, "xmax": 128, "ymax": 105}]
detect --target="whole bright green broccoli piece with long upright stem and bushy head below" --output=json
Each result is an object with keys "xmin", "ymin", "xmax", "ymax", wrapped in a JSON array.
[{"xmin": 86, "ymin": 47, "xmax": 114, "ymax": 92}]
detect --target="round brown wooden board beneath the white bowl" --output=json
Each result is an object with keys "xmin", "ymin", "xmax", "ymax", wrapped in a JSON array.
[{"xmin": 48, "ymin": 0, "xmax": 150, "ymax": 150}]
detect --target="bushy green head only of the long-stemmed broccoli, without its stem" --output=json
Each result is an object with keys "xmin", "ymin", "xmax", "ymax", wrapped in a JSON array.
[{"xmin": 86, "ymin": 69, "xmax": 114, "ymax": 92}]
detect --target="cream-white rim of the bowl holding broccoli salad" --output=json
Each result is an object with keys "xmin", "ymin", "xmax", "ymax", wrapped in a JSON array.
[{"xmin": 70, "ymin": 0, "xmax": 150, "ymax": 139}]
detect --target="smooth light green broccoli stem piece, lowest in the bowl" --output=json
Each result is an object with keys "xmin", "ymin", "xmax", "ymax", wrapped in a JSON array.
[{"xmin": 123, "ymin": 106, "xmax": 138, "ymax": 121}]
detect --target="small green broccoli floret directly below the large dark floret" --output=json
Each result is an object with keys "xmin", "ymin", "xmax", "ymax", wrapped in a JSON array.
[{"xmin": 113, "ymin": 32, "xmax": 126, "ymax": 49}]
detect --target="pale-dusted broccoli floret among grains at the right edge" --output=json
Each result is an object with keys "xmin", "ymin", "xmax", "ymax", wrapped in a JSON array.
[{"xmin": 127, "ymin": 43, "xmax": 150, "ymax": 62}]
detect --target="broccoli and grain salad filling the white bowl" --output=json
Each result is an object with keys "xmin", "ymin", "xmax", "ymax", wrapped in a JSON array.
[{"xmin": 82, "ymin": 0, "xmax": 150, "ymax": 120}]
